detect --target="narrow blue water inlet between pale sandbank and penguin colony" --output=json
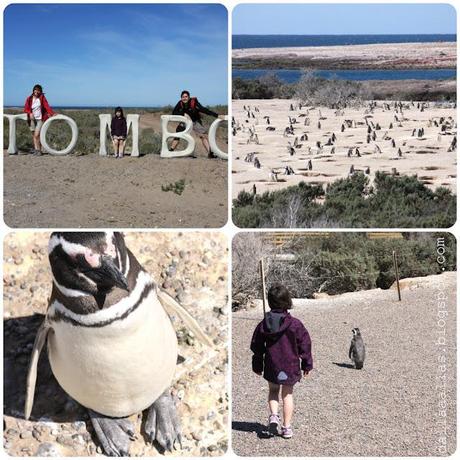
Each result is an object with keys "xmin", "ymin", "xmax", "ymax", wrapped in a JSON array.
[{"xmin": 232, "ymin": 69, "xmax": 457, "ymax": 83}]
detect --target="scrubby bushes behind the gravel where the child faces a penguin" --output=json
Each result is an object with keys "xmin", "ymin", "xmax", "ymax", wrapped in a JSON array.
[{"xmin": 258, "ymin": 233, "xmax": 457, "ymax": 298}]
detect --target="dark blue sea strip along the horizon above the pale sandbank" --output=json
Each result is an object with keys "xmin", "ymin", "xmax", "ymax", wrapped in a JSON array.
[{"xmin": 232, "ymin": 34, "xmax": 457, "ymax": 49}]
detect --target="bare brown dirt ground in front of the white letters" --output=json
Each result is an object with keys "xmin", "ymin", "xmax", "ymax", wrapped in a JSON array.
[{"xmin": 3, "ymin": 114, "xmax": 228, "ymax": 228}]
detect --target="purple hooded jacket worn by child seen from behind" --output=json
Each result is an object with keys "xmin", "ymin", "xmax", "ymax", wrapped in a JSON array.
[{"xmin": 251, "ymin": 310, "xmax": 313, "ymax": 385}]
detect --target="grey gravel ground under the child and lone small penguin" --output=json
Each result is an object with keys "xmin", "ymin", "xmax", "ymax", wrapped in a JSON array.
[{"xmin": 232, "ymin": 272, "xmax": 456, "ymax": 456}]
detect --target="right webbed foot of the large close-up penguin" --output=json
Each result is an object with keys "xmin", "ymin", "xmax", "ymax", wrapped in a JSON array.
[{"xmin": 145, "ymin": 390, "xmax": 182, "ymax": 452}]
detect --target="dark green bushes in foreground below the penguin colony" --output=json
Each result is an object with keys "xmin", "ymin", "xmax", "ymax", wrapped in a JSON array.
[{"xmin": 233, "ymin": 172, "xmax": 456, "ymax": 228}]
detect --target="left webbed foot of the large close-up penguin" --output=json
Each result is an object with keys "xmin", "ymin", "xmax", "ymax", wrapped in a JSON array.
[{"xmin": 88, "ymin": 410, "xmax": 134, "ymax": 457}]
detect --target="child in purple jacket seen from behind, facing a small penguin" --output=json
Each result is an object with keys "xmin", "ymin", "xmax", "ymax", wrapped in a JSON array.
[{"xmin": 251, "ymin": 284, "xmax": 313, "ymax": 438}]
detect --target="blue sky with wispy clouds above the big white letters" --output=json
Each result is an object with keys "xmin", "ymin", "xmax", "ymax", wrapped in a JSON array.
[{"xmin": 4, "ymin": 4, "xmax": 228, "ymax": 107}]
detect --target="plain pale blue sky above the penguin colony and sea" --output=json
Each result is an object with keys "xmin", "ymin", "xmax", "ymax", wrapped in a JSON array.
[{"xmin": 232, "ymin": 3, "xmax": 456, "ymax": 35}]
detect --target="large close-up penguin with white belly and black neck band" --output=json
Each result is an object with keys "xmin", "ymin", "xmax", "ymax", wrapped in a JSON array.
[{"xmin": 25, "ymin": 232, "xmax": 217, "ymax": 456}]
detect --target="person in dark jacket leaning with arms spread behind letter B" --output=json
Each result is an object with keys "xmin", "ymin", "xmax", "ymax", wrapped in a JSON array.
[{"xmin": 170, "ymin": 90, "xmax": 219, "ymax": 158}]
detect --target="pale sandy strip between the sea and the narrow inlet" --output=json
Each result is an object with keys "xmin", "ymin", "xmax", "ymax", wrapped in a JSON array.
[{"xmin": 232, "ymin": 42, "xmax": 457, "ymax": 69}]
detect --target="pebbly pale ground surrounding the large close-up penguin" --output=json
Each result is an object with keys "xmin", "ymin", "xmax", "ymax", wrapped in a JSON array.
[{"xmin": 3, "ymin": 232, "xmax": 228, "ymax": 456}]
